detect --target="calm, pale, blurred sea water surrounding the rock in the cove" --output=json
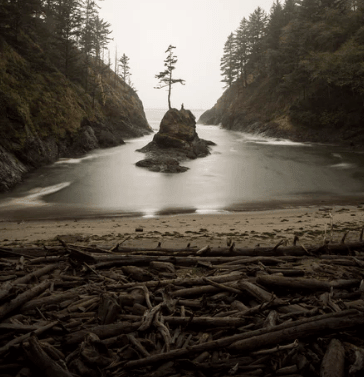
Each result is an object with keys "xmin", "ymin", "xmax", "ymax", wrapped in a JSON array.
[{"xmin": 0, "ymin": 110, "xmax": 364, "ymax": 220}]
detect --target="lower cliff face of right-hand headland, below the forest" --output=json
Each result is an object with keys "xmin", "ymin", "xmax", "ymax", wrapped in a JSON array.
[{"xmin": 198, "ymin": 77, "xmax": 364, "ymax": 146}]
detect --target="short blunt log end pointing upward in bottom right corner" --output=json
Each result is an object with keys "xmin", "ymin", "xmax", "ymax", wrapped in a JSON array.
[{"xmin": 320, "ymin": 339, "xmax": 345, "ymax": 377}]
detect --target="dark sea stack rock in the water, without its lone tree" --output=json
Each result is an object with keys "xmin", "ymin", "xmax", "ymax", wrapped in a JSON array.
[{"xmin": 136, "ymin": 108, "xmax": 215, "ymax": 173}]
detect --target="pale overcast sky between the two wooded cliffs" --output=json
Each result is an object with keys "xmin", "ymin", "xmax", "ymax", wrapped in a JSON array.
[{"xmin": 99, "ymin": 0, "xmax": 273, "ymax": 109}]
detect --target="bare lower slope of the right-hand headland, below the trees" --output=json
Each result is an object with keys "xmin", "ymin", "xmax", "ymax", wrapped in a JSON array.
[{"xmin": 198, "ymin": 79, "xmax": 364, "ymax": 147}]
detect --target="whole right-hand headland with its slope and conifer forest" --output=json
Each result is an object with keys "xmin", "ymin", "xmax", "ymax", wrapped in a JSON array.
[{"xmin": 199, "ymin": 0, "xmax": 364, "ymax": 144}]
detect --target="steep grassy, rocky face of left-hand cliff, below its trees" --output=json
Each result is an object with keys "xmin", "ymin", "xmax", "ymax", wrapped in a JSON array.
[{"xmin": 0, "ymin": 39, "xmax": 152, "ymax": 191}]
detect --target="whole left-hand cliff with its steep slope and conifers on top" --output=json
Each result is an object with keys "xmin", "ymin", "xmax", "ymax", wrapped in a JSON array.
[{"xmin": 0, "ymin": 0, "xmax": 151, "ymax": 191}]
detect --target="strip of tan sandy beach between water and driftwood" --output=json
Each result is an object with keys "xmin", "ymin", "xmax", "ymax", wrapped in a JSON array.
[{"xmin": 0, "ymin": 204, "xmax": 364, "ymax": 248}]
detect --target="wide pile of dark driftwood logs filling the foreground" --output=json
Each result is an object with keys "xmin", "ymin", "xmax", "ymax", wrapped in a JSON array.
[{"xmin": 0, "ymin": 235, "xmax": 364, "ymax": 377}]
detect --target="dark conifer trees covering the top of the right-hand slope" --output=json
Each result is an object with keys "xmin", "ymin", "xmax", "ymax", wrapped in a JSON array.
[{"xmin": 221, "ymin": 0, "xmax": 364, "ymax": 127}]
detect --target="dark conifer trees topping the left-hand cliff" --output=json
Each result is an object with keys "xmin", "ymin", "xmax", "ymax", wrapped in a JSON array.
[{"xmin": 0, "ymin": 0, "xmax": 121, "ymax": 93}]
